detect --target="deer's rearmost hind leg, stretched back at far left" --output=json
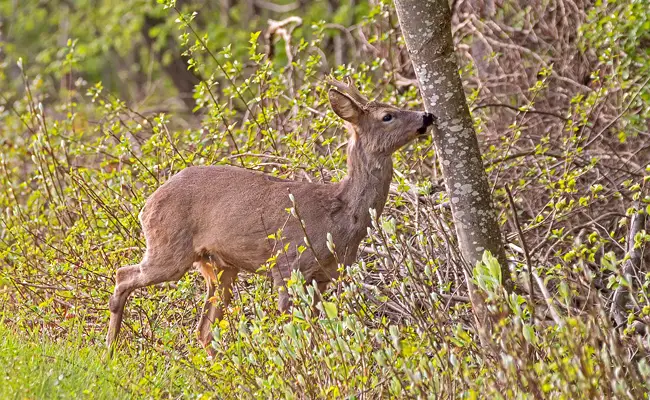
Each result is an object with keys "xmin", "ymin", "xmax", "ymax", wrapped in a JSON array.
[{"xmin": 106, "ymin": 250, "xmax": 194, "ymax": 357}]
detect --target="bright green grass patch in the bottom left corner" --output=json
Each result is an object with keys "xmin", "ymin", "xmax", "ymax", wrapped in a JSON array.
[{"xmin": 0, "ymin": 323, "xmax": 208, "ymax": 399}]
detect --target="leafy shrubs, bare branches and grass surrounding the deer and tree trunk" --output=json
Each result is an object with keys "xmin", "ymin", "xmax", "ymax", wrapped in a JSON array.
[{"xmin": 0, "ymin": 0, "xmax": 650, "ymax": 399}]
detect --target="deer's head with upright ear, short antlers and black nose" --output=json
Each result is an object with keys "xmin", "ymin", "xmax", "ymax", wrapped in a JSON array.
[{"xmin": 329, "ymin": 80, "xmax": 435, "ymax": 156}]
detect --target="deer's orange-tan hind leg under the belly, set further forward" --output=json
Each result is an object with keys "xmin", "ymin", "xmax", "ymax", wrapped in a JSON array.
[{"xmin": 196, "ymin": 260, "xmax": 237, "ymax": 357}]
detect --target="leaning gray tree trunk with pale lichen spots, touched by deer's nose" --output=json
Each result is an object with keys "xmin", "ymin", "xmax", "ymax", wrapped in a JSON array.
[{"xmin": 395, "ymin": 0, "xmax": 510, "ymax": 282}]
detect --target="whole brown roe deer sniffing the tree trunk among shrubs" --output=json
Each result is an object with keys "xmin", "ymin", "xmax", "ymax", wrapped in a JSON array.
[{"xmin": 107, "ymin": 80, "xmax": 434, "ymax": 356}]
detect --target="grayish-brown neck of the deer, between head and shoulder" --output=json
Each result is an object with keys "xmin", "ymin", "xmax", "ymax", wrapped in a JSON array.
[{"xmin": 340, "ymin": 135, "xmax": 393, "ymax": 227}]
